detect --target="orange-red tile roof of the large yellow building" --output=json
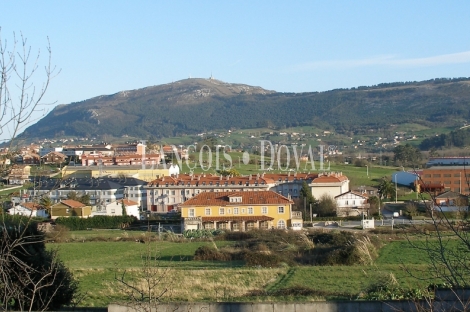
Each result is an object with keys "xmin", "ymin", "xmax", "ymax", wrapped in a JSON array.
[{"xmin": 181, "ymin": 191, "xmax": 293, "ymax": 206}]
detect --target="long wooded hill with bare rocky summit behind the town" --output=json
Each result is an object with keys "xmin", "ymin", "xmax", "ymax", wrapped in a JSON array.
[{"xmin": 21, "ymin": 78, "xmax": 470, "ymax": 139}]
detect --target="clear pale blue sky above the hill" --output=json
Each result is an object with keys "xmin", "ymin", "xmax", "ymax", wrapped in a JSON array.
[{"xmin": 0, "ymin": 0, "xmax": 470, "ymax": 104}]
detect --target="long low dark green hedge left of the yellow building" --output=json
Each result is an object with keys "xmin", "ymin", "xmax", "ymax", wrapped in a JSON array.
[{"xmin": 55, "ymin": 216, "xmax": 137, "ymax": 231}]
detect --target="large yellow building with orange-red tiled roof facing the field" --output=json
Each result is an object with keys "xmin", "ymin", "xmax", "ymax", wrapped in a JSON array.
[{"xmin": 181, "ymin": 191, "xmax": 302, "ymax": 231}]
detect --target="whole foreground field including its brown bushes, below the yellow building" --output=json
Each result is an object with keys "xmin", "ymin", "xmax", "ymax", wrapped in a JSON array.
[{"xmin": 48, "ymin": 230, "xmax": 446, "ymax": 306}]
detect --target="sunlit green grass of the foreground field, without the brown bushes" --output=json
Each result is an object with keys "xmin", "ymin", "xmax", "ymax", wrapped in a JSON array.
[{"xmin": 52, "ymin": 231, "xmax": 444, "ymax": 306}]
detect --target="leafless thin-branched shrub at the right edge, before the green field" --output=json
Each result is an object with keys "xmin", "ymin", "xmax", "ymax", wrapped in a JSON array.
[{"xmin": 398, "ymin": 171, "xmax": 470, "ymax": 311}]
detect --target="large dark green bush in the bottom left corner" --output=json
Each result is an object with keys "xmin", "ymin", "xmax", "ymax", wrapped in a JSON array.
[{"xmin": 0, "ymin": 215, "xmax": 78, "ymax": 311}]
